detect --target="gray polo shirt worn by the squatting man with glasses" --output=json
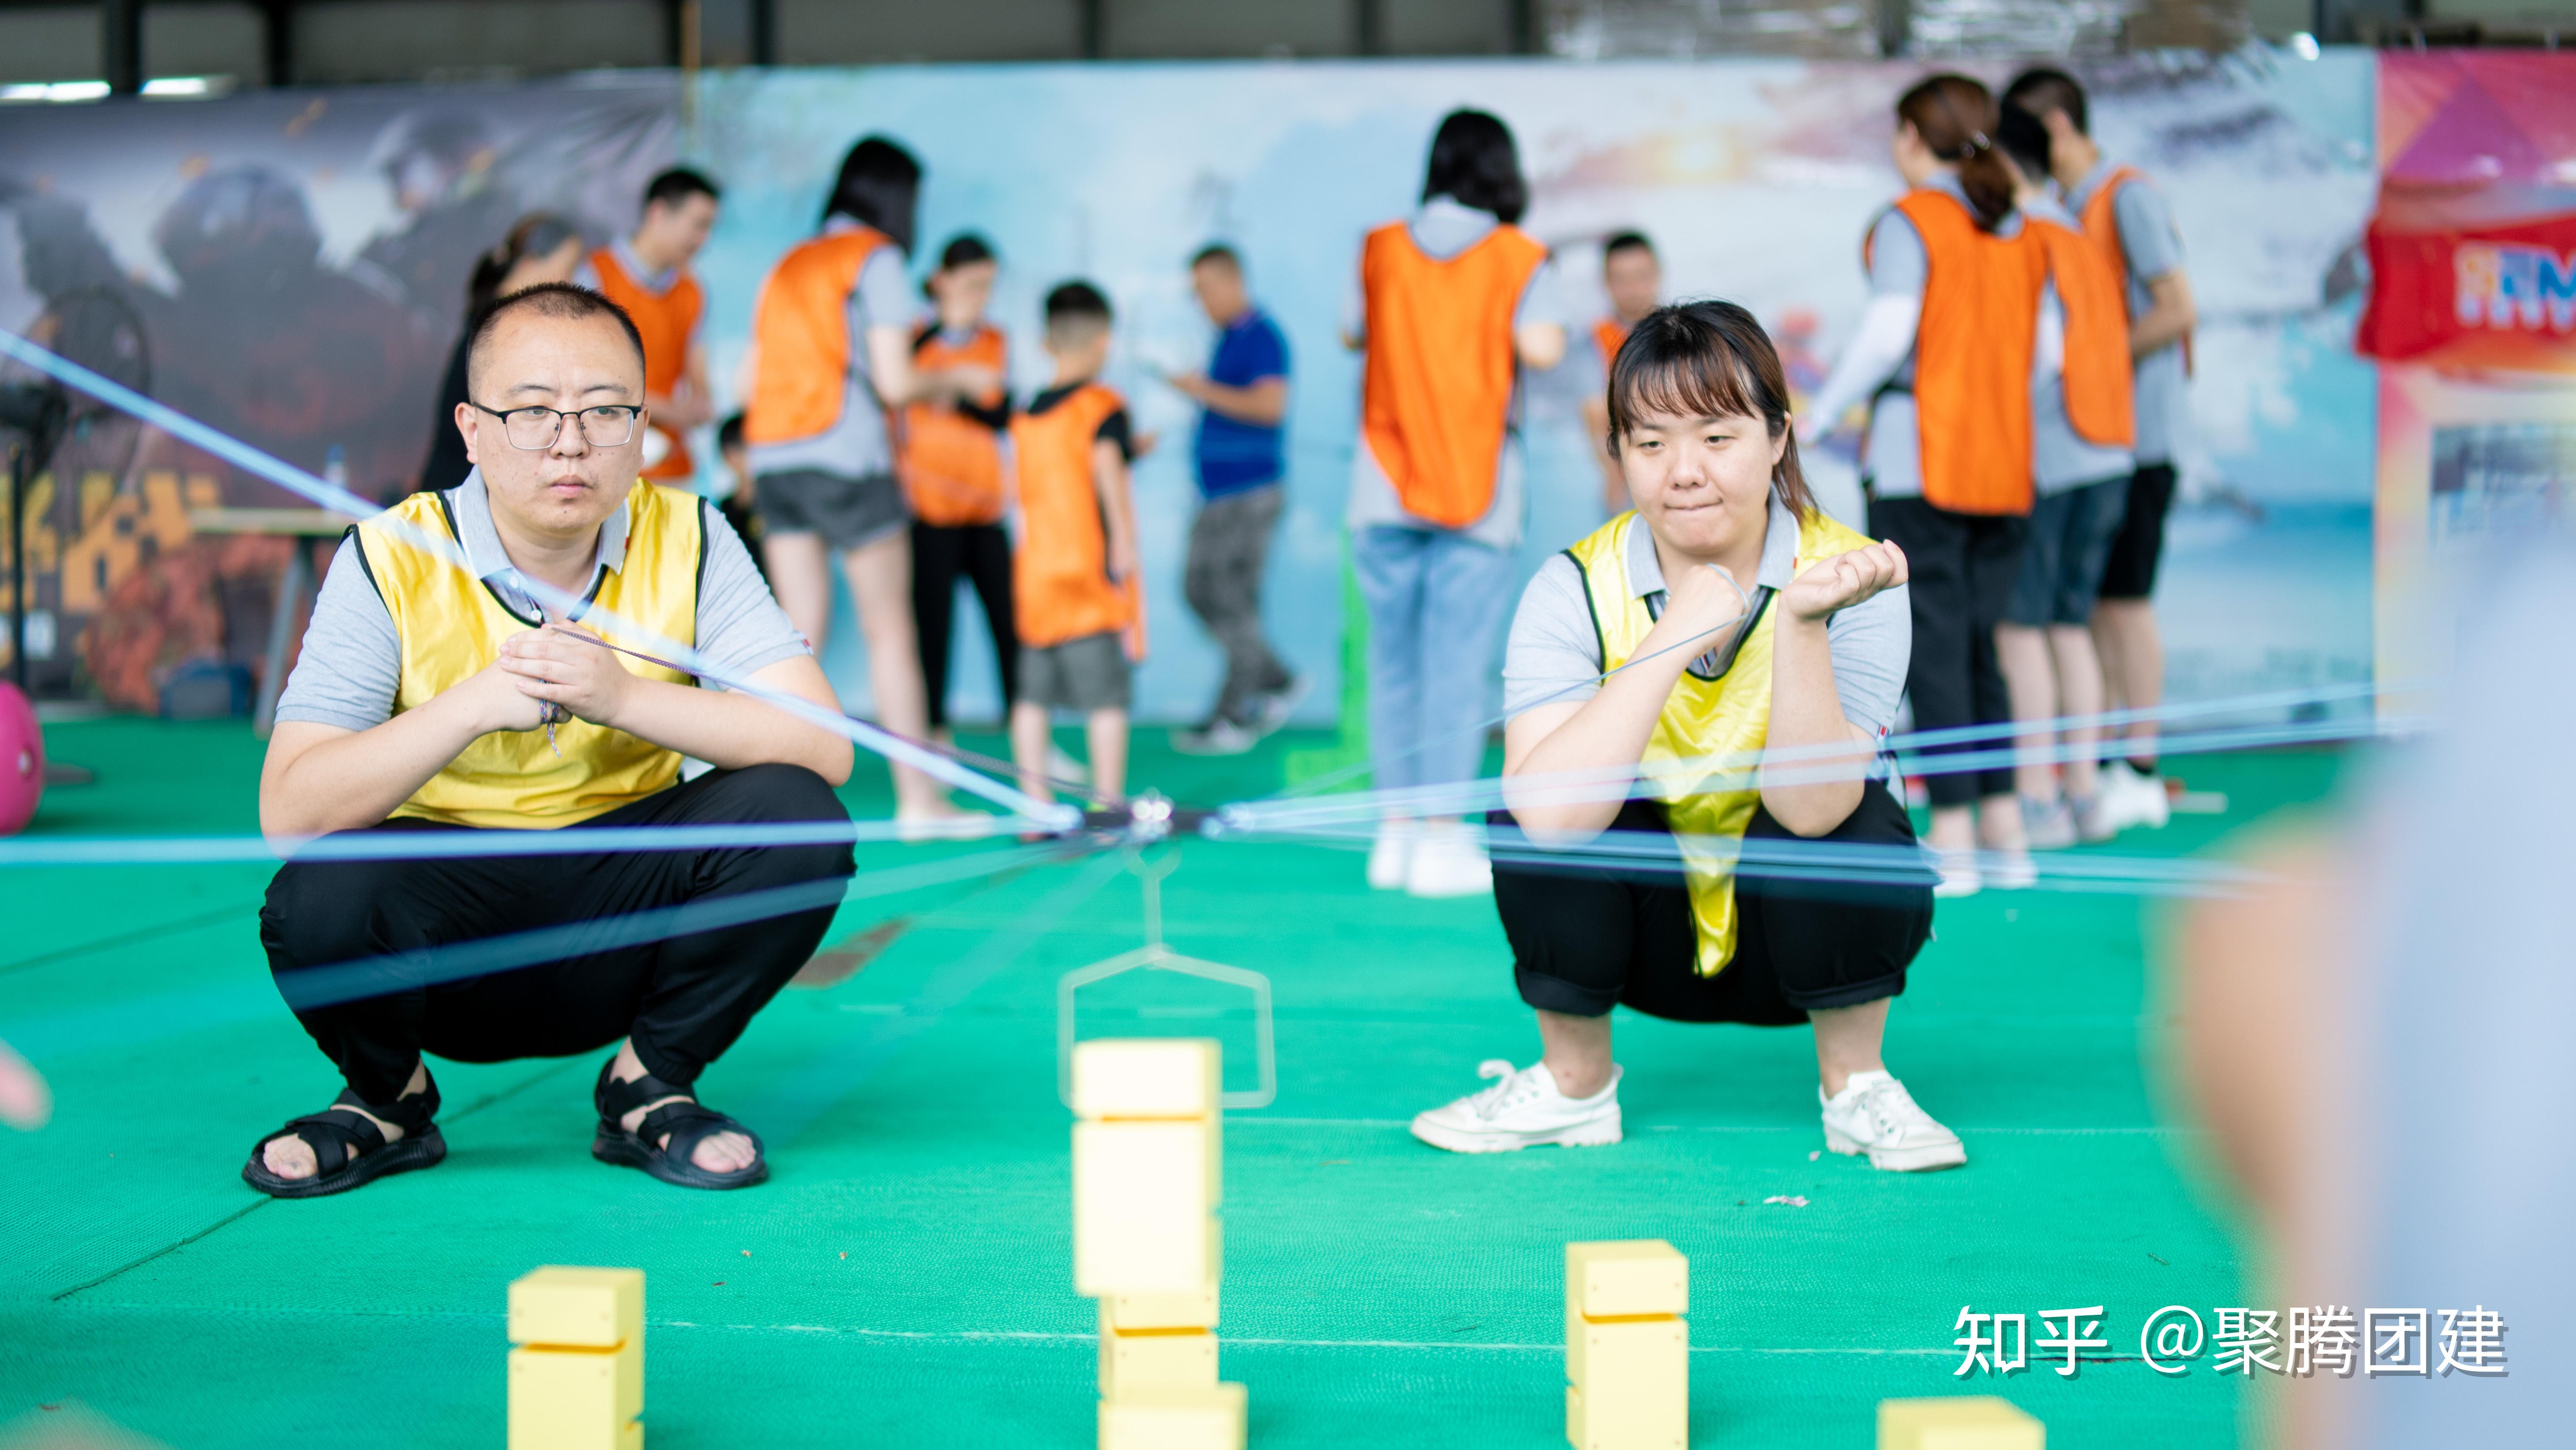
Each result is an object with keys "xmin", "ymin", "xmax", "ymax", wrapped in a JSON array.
[{"xmin": 278, "ymin": 469, "xmax": 814, "ymax": 729}]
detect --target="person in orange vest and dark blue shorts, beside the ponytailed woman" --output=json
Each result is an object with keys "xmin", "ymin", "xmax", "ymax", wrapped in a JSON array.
[{"xmin": 1994, "ymin": 106, "xmax": 2136, "ymax": 850}]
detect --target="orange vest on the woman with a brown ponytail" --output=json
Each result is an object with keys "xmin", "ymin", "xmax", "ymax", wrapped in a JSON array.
[{"xmin": 1862, "ymin": 188, "xmax": 2048, "ymax": 515}]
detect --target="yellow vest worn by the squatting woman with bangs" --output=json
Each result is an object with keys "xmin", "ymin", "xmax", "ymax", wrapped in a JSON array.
[{"xmin": 1566, "ymin": 510, "xmax": 1870, "ymax": 976}]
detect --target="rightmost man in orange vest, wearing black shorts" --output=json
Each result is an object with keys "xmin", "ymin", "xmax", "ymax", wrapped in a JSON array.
[{"xmin": 2004, "ymin": 67, "xmax": 2197, "ymax": 827}]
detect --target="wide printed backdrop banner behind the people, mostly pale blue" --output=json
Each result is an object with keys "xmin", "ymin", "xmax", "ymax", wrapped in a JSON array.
[{"xmin": 0, "ymin": 52, "xmax": 2378, "ymax": 724}]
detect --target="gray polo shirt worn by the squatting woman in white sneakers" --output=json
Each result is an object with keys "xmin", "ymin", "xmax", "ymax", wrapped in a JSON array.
[{"xmin": 1502, "ymin": 494, "xmax": 1914, "ymax": 734}]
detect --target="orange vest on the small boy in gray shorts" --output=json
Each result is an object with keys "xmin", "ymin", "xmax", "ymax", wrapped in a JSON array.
[{"xmin": 1010, "ymin": 384, "xmax": 1144, "ymax": 659}]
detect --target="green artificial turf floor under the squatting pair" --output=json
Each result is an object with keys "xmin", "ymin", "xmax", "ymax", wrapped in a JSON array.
[{"xmin": 0, "ymin": 719, "xmax": 2337, "ymax": 1450}]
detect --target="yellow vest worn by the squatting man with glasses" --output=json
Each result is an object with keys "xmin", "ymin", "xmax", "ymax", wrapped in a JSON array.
[{"xmin": 353, "ymin": 479, "xmax": 706, "ymax": 827}]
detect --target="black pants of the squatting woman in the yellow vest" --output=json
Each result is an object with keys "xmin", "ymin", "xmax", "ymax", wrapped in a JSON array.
[{"xmin": 1494, "ymin": 783, "xmax": 1932, "ymax": 1028}]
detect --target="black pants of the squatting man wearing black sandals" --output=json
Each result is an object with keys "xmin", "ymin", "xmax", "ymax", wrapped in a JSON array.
[{"xmin": 260, "ymin": 765, "xmax": 853, "ymax": 1102}]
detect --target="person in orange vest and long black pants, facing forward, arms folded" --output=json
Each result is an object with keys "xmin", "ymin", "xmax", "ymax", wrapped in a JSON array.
[{"xmin": 894, "ymin": 232, "xmax": 1020, "ymax": 757}]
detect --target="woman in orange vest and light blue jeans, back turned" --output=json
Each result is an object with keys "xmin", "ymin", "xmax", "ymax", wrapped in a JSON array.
[{"xmin": 1342, "ymin": 111, "xmax": 1566, "ymax": 896}]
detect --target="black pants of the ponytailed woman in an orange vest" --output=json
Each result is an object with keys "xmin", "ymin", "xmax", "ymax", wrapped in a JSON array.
[{"xmin": 1870, "ymin": 497, "xmax": 2030, "ymax": 806}]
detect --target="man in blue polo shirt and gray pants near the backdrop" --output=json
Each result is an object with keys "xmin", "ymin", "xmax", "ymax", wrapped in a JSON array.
[{"xmin": 1169, "ymin": 245, "xmax": 1306, "ymax": 755}]
